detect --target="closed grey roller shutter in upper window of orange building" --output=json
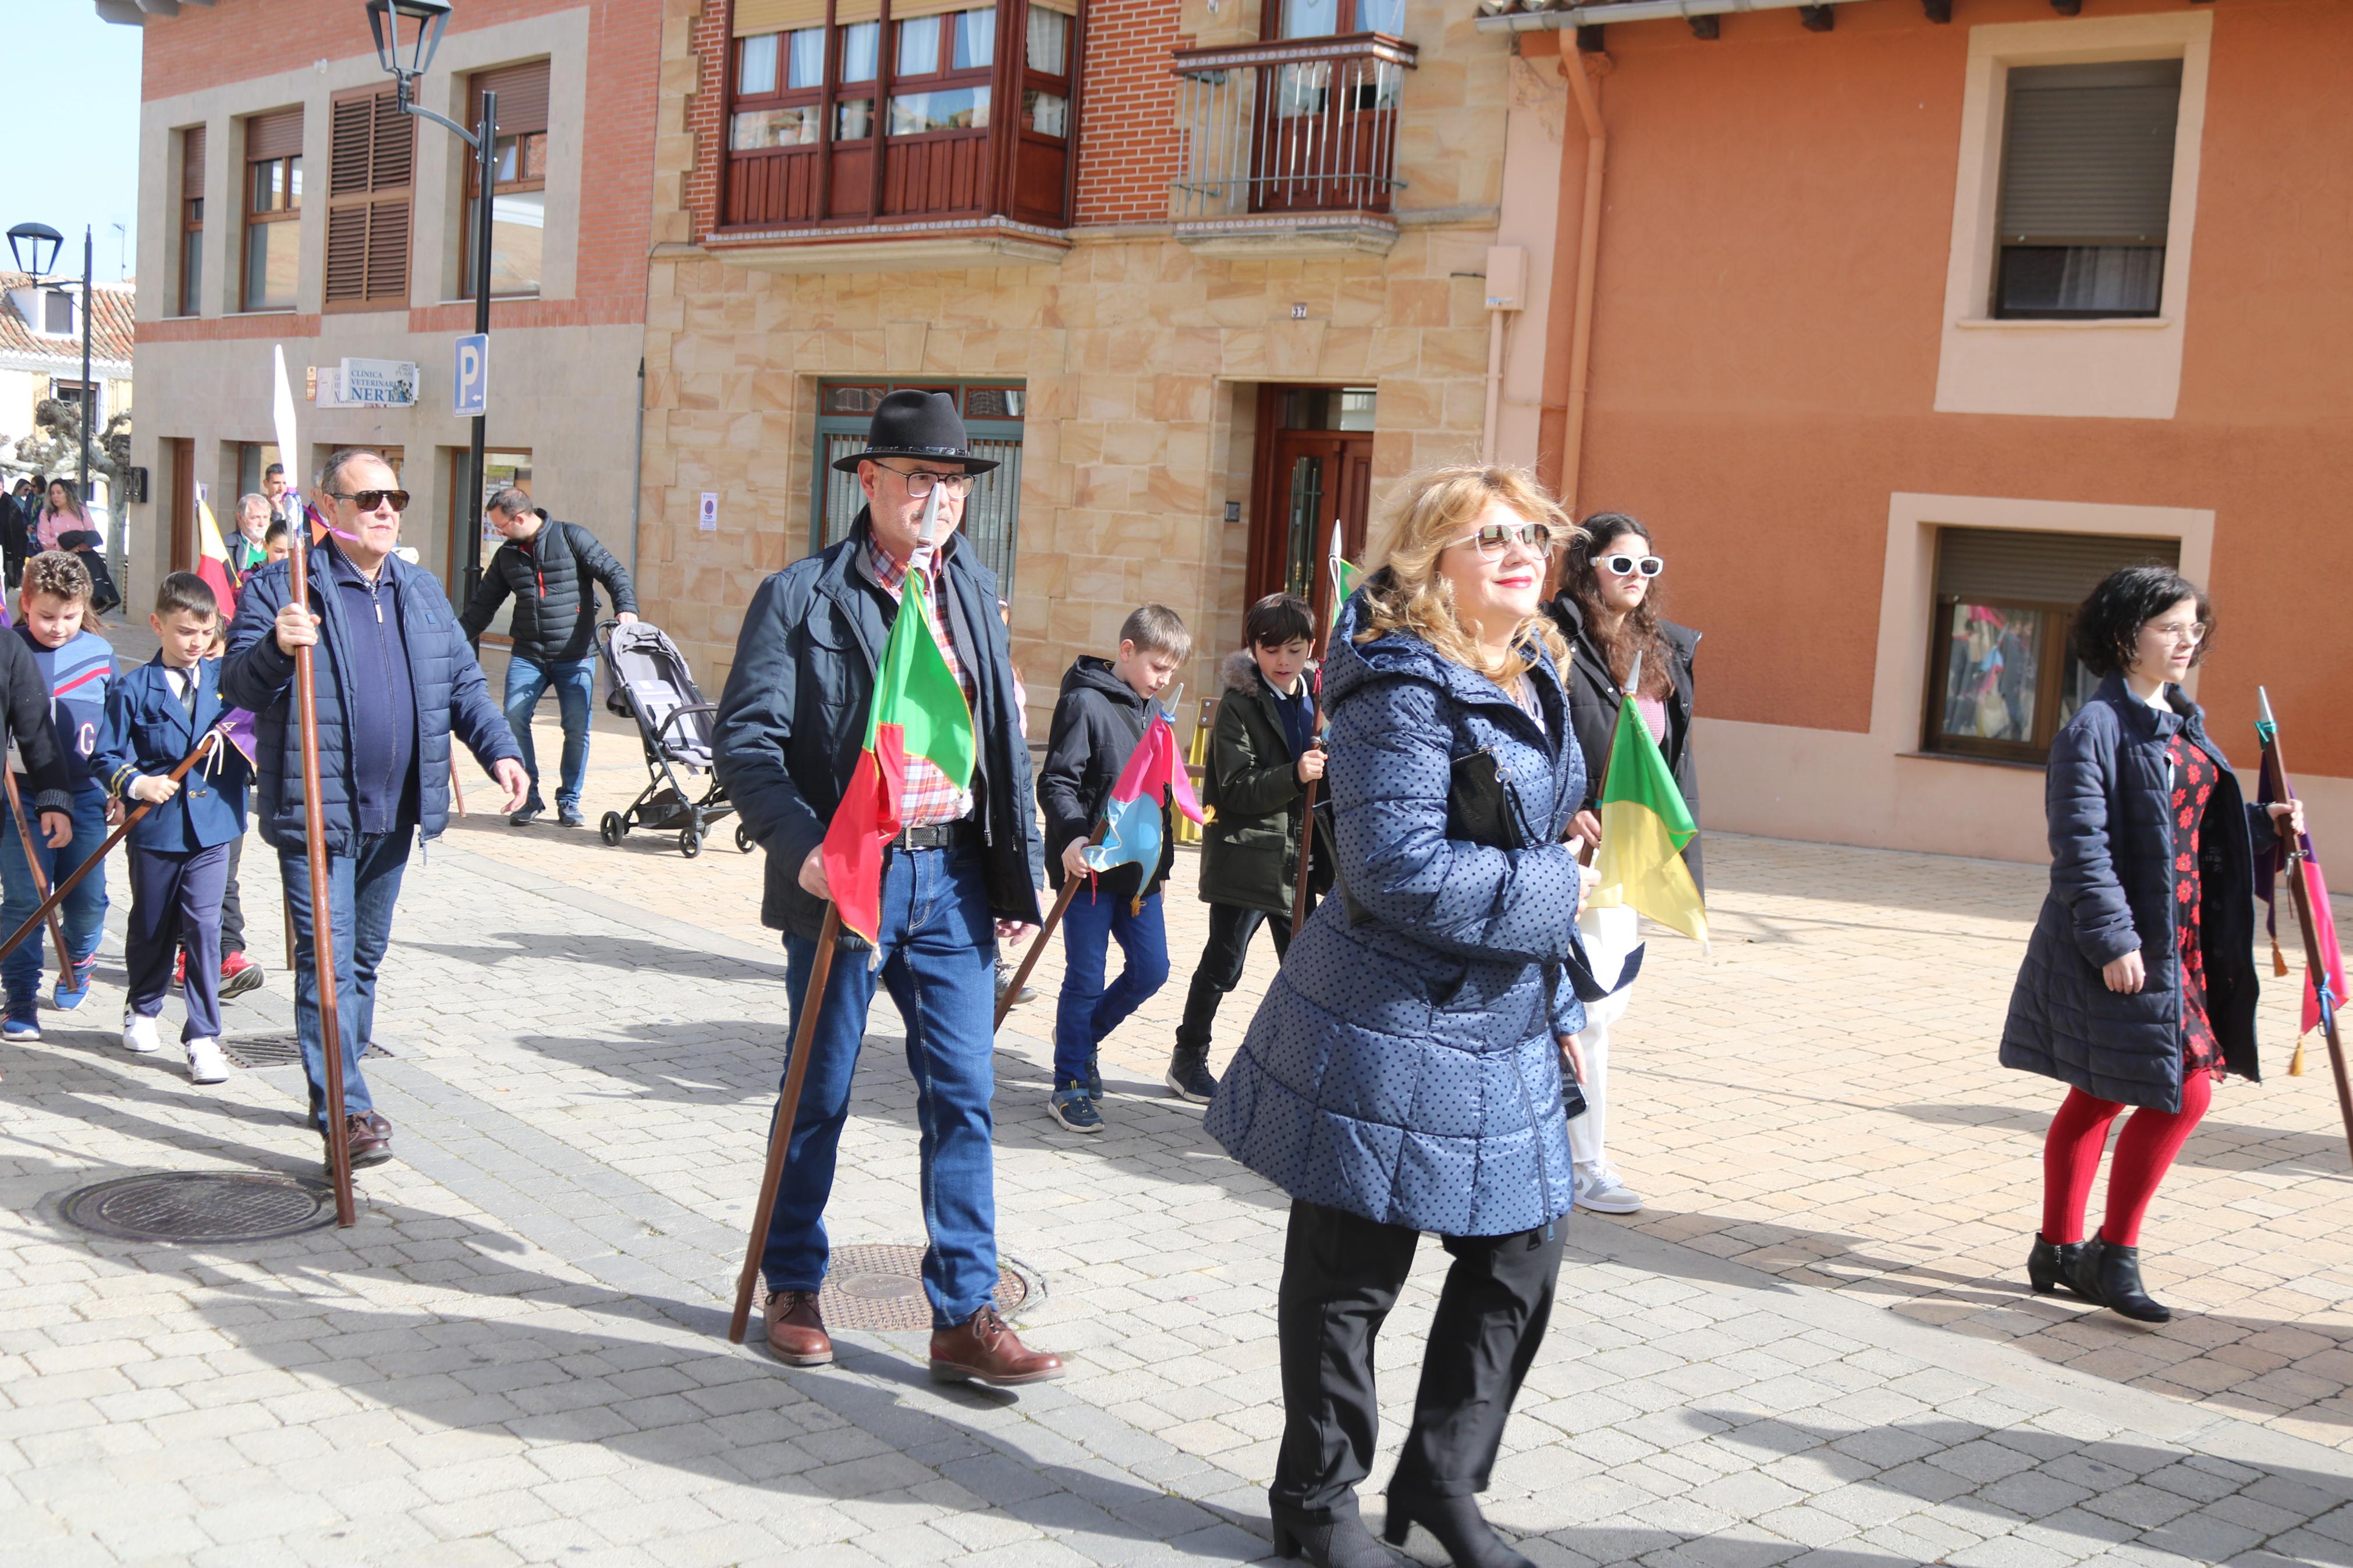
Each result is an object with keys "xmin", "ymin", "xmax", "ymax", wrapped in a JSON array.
[{"xmin": 2000, "ymin": 59, "xmax": 2181, "ymax": 244}]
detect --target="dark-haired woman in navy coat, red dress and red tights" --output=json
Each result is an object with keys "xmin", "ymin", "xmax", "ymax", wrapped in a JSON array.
[{"xmin": 2003, "ymin": 567, "xmax": 2304, "ymax": 1324}]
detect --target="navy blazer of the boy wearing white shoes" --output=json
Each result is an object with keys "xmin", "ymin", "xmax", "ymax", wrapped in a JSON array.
[{"xmin": 90, "ymin": 653, "xmax": 252, "ymax": 856}]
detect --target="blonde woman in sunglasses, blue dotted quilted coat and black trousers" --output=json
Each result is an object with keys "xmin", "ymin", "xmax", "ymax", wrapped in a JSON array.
[{"xmin": 1207, "ymin": 465, "xmax": 1586, "ymax": 1568}]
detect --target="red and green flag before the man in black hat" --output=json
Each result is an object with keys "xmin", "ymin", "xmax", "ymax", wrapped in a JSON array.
[{"xmin": 824, "ymin": 567, "xmax": 974, "ymax": 943}]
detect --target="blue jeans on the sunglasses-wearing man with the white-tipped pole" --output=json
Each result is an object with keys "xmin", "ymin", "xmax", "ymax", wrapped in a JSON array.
[{"xmin": 278, "ymin": 827, "xmax": 417, "ymax": 1130}]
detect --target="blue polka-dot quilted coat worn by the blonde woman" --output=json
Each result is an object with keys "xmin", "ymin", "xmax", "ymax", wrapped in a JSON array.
[{"xmin": 1207, "ymin": 592, "xmax": 1586, "ymax": 1236}]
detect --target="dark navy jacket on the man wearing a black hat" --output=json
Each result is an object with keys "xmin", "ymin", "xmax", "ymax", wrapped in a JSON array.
[{"xmin": 713, "ymin": 510, "xmax": 1042, "ymax": 943}]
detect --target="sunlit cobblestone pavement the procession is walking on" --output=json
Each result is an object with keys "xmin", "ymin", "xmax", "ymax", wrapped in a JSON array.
[{"xmin": 0, "ymin": 710, "xmax": 2353, "ymax": 1568}]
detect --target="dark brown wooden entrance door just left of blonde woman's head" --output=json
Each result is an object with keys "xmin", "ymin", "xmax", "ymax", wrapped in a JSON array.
[{"xmin": 1250, "ymin": 386, "xmax": 1374, "ymax": 625}]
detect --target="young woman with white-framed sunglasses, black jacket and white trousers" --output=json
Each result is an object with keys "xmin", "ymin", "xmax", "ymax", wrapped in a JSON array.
[{"xmin": 1550, "ymin": 513, "xmax": 1699, "ymax": 1213}]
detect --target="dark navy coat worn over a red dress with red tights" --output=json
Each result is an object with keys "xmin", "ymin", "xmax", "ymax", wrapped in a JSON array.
[{"xmin": 2003, "ymin": 675, "xmax": 2270, "ymax": 1112}]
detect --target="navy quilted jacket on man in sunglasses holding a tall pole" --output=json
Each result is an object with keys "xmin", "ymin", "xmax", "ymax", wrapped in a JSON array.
[{"xmin": 221, "ymin": 545, "xmax": 523, "ymax": 856}]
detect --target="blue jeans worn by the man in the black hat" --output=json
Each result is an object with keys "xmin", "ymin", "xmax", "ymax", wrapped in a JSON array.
[{"xmin": 760, "ymin": 849, "xmax": 998, "ymax": 1328}]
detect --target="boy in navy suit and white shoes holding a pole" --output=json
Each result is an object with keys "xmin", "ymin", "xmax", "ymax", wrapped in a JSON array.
[{"xmin": 97, "ymin": 571, "xmax": 250, "ymax": 1084}]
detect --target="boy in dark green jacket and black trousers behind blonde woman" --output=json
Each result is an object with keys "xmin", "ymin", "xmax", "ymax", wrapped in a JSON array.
[{"xmin": 1167, "ymin": 592, "xmax": 1332, "ymax": 1105}]
